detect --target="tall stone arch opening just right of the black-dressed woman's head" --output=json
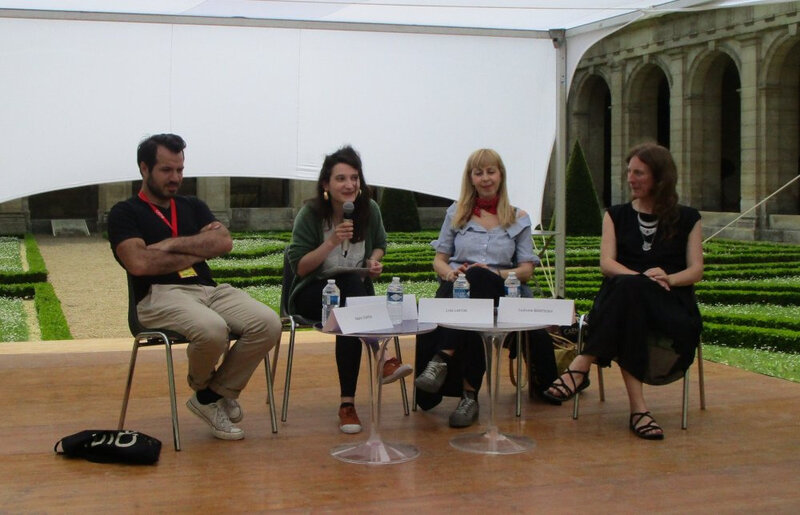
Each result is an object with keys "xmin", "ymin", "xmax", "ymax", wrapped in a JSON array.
[{"xmin": 684, "ymin": 50, "xmax": 742, "ymax": 211}]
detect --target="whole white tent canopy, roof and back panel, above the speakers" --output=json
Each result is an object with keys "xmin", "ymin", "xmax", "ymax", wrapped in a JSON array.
[{"xmin": 0, "ymin": 0, "xmax": 756, "ymax": 222}]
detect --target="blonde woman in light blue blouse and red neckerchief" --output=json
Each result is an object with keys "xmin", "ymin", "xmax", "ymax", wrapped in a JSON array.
[{"xmin": 415, "ymin": 149, "xmax": 557, "ymax": 427}]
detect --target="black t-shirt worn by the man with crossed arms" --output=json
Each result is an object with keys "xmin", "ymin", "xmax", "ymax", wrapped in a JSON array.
[{"xmin": 108, "ymin": 197, "xmax": 216, "ymax": 303}]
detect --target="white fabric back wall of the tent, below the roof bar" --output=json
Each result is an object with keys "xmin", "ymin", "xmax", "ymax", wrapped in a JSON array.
[{"xmin": 0, "ymin": 19, "xmax": 557, "ymax": 221}]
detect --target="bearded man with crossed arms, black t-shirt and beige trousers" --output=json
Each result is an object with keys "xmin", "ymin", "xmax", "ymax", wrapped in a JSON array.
[{"xmin": 108, "ymin": 134, "xmax": 281, "ymax": 440}]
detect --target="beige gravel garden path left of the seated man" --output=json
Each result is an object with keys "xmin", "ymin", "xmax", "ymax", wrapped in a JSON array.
[{"xmin": 36, "ymin": 234, "xmax": 131, "ymax": 339}]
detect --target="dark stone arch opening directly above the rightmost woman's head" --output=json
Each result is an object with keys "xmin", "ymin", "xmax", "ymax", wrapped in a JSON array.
[{"xmin": 625, "ymin": 60, "xmax": 671, "ymax": 147}]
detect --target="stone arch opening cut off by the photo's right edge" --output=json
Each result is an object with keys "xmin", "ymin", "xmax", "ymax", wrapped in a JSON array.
[{"xmin": 760, "ymin": 35, "xmax": 800, "ymax": 214}]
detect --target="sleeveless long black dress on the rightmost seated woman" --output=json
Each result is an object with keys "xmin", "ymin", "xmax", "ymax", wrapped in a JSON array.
[{"xmin": 584, "ymin": 203, "xmax": 703, "ymax": 384}]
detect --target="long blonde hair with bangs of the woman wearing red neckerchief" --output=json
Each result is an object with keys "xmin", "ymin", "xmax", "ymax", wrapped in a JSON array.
[{"xmin": 453, "ymin": 148, "xmax": 517, "ymax": 229}]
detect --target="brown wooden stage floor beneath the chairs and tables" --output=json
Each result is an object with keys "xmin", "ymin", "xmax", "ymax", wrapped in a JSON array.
[{"xmin": 0, "ymin": 332, "xmax": 800, "ymax": 513}]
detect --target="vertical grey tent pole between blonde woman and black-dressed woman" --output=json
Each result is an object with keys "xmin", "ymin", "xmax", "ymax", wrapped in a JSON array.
[{"xmin": 550, "ymin": 29, "xmax": 567, "ymax": 298}]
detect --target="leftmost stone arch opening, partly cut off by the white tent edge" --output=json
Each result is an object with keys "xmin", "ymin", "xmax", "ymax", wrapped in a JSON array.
[{"xmin": 570, "ymin": 73, "xmax": 611, "ymax": 206}]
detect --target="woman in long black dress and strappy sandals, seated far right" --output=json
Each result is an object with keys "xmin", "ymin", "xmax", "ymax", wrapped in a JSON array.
[{"xmin": 545, "ymin": 143, "xmax": 703, "ymax": 440}]
